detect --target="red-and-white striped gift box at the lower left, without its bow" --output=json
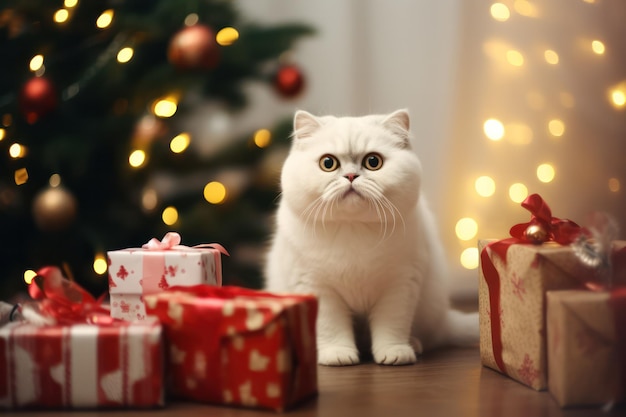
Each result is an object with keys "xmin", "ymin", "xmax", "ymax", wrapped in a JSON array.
[{"xmin": 0, "ymin": 320, "xmax": 164, "ymax": 409}]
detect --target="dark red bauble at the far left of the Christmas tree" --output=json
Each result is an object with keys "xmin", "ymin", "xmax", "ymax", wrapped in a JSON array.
[{"xmin": 20, "ymin": 77, "xmax": 59, "ymax": 123}]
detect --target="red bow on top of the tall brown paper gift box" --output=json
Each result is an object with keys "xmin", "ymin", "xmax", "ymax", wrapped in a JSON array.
[{"xmin": 509, "ymin": 194, "xmax": 582, "ymax": 245}]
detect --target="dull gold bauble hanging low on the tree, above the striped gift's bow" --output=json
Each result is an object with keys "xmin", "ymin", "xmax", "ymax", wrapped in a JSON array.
[{"xmin": 33, "ymin": 186, "xmax": 77, "ymax": 232}]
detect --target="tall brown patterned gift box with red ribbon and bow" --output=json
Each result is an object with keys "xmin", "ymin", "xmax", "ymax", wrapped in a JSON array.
[{"xmin": 478, "ymin": 194, "xmax": 626, "ymax": 390}]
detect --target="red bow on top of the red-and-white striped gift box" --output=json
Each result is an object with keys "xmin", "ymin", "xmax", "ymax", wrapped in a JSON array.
[{"xmin": 28, "ymin": 266, "xmax": 118, "ymax": 325}]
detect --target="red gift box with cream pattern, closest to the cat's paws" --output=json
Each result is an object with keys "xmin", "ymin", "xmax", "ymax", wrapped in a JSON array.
[{"xmin": 145, "ymin": 285, "xmax": 318, "ymax": 410}]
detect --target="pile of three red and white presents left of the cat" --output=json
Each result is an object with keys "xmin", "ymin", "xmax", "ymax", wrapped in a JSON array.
[{"xmin": 0, "ymin": 233, "xmax": 318, "ymax": 411}]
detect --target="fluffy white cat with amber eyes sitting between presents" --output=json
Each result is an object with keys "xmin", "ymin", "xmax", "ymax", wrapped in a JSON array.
[{"xmin": 265, "ymin": 110, "xmax": 478, "ymax": 365}]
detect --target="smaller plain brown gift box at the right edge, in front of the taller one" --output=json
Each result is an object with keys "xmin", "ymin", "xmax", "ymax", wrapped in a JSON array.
[{"xmin": 547, "ymin": 288, "xmax": 626, "ymax": 406}]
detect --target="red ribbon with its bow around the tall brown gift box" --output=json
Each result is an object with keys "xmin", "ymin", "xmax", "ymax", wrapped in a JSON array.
[{"xmin": 480, "ymin": 194, "xmax": 582, "ymax": 374}]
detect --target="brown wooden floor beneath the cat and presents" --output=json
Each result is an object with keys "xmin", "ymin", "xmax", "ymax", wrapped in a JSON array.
[{"xmin": 0, "ymin": 349, "xmax": 626, "ymax": 417}]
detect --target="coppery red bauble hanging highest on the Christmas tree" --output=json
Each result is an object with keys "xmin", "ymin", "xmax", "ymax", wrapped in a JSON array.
[{"xmin": 167, "ymin": 24, "xmax": 220, "ymax": 70}]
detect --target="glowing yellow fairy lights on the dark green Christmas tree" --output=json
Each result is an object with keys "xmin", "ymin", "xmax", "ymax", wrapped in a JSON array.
[{"xmin": 0, "ymin": 0, "xmax": 282, "ymax": 283}]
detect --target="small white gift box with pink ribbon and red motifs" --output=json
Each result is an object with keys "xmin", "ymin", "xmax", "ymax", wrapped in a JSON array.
[{"xmin": 107, "ymin": 232, "xmax": 228, "ymax": 320}]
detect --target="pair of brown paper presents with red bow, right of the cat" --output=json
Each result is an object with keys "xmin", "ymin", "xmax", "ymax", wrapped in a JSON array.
[{"xmin": 478, "ymin": 194, "xmax": 626, "ymax": 407}]
